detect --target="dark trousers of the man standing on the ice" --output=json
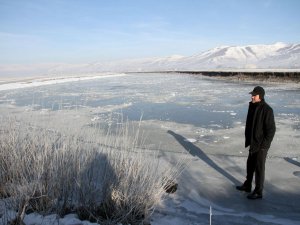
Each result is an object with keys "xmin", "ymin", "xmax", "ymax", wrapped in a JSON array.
[{"xmin": 244, "ymin": 149, "xmax": 268, "ymax": 194}]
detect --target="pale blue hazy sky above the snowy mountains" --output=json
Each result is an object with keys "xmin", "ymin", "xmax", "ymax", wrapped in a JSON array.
[{"xmin": 0, "ymin": 0, "xmax": 300, "ymax": 65}]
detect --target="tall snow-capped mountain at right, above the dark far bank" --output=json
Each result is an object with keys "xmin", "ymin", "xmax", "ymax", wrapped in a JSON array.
[{"xmin": 187, "ymin": 43, "xmax": 300, "ymax": 69}]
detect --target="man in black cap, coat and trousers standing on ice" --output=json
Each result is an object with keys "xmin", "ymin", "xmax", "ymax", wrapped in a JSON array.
[{"xmin": 236, "ymin": 86, "xmax": 276, "ymax": 199}]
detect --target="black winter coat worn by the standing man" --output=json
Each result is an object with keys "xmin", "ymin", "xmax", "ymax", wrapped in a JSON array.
[{"xmin": 245, "ymin": 100, "xmax": 276, "ymax": 152}]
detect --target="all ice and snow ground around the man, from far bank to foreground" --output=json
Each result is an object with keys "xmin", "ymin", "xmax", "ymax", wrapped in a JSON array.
[{"xmin": 0, "ymin": 74, "xmax": 300, "ymax": 225}]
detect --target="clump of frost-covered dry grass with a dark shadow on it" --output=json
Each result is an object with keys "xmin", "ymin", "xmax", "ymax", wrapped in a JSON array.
[{"xmin": 0, "ymin": 117, "xmax": 183, "ymax": 224}]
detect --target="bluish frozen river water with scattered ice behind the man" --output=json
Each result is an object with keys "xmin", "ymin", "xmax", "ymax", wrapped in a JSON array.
[{"xmin": 0, "ymin": 73, "xmax": 300, "ymax": 129}]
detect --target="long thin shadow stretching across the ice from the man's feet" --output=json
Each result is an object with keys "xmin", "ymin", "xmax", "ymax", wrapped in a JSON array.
[{"xmin": 168, "ymin": 130, "xmax": 240, "ymax": 185}]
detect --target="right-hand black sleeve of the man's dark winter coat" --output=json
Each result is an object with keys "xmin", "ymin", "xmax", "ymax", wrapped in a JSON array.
[{"xmin": 261, "ymin": 108, "xmax": 276, "ymax": 149}]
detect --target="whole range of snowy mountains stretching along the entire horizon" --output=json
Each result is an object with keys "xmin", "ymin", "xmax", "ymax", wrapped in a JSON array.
[{"xmin": 0, "ymin": 42, "xmax": 300, "ymax": 76}]
